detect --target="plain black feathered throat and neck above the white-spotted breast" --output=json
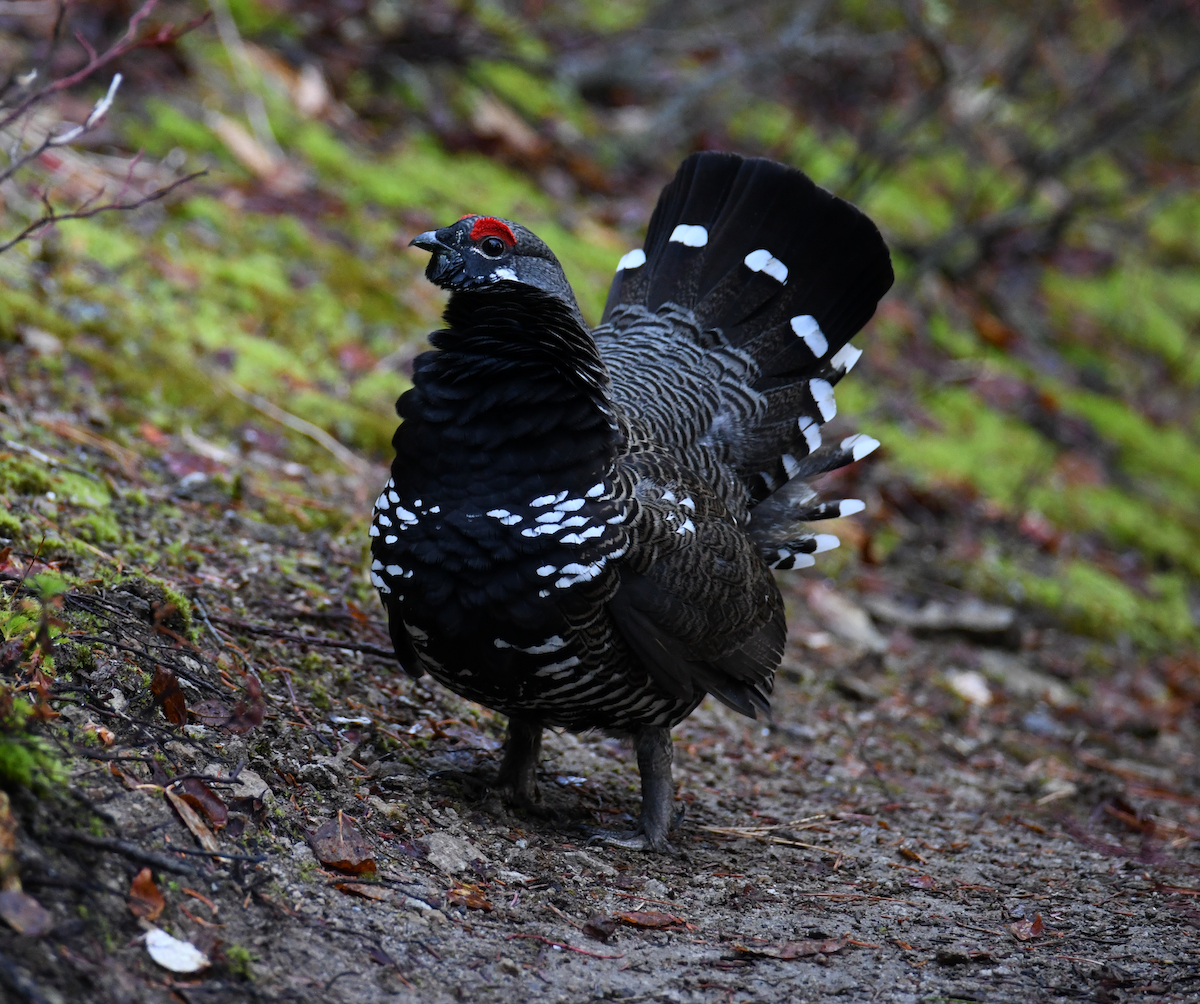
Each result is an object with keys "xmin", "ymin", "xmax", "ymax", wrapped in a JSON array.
[{"xmin": 392, "ymin": 282, "xmax": 620, "ymax": 498}]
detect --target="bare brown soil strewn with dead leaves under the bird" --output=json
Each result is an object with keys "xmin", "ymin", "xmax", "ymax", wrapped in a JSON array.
[{"xmin": 0, "ymin": 422, "xmax": 1200, "ymax": 1004}]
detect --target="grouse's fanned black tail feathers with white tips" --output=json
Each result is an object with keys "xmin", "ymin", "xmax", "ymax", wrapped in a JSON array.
[{"xmin": 604, "ymin": 152, "xmax": 893, "ymax": 567}]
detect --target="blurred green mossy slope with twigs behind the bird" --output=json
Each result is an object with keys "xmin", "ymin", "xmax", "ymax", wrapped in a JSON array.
[{"xmin": 0, "ymin": 0, "xmax": 1200, "ymax": 649}]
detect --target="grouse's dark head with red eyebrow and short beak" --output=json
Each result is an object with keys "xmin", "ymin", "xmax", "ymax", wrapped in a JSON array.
[{"xmin": 409, "ymin": 216, "xmax": 575, "ymax": 305}]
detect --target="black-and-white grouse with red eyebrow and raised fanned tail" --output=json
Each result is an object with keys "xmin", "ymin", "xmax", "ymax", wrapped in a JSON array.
[{"xmin": 368, "ymin": 151, "xmax": 893, "ymax": 852}]
